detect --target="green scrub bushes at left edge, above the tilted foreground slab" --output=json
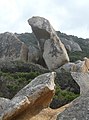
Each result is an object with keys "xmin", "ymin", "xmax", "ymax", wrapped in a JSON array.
[{"xmin": 0, "ymin": 71, "xmax": 40, "ymax": 98}]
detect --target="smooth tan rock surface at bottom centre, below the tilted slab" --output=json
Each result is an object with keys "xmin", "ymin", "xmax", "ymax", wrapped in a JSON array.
[{"xmin": 18, "ymin": 104, "xmax": 69, "ymax": 120}]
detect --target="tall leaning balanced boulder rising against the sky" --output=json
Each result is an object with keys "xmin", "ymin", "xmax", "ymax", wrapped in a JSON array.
[{"xmin": 28, "ymin": 17, "xmax": 69, "ymax": 70}]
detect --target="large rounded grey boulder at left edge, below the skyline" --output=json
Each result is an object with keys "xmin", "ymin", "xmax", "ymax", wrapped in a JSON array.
[{"xmin": 0, "ymin": 32, "xmax": 28, "ymax": 61}]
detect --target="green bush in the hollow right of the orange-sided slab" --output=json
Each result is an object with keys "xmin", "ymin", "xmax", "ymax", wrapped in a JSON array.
[{"xmin": 50, "ymin": 85, "xmax": 79, "ymax": 109}]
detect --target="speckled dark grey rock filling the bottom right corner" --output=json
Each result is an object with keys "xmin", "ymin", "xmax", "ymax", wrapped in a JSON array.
[{"xmin": 56, "ymin": 91, "xmax": 89, "ymax": 120}]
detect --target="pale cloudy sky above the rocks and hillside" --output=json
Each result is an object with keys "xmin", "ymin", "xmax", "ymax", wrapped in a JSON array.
[{"xmin": 0, "ymin": 0, "xmax": 89, "ymax": 38}]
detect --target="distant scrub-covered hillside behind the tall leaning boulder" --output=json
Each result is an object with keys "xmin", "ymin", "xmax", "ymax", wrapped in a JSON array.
[{"xmin": 15, "ymin": 31, "xmax": 89, "ymax": 62}]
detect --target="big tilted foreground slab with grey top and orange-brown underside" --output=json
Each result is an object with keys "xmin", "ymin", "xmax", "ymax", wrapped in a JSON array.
[{"xmin": 0, "ymin": 72, "xmax": 55, "ymax": 120}]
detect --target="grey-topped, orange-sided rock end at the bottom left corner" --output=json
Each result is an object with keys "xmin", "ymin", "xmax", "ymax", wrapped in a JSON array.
[{"xmin": 0, "ymin": 96, "xmax": 30, "ymax": 120}]
